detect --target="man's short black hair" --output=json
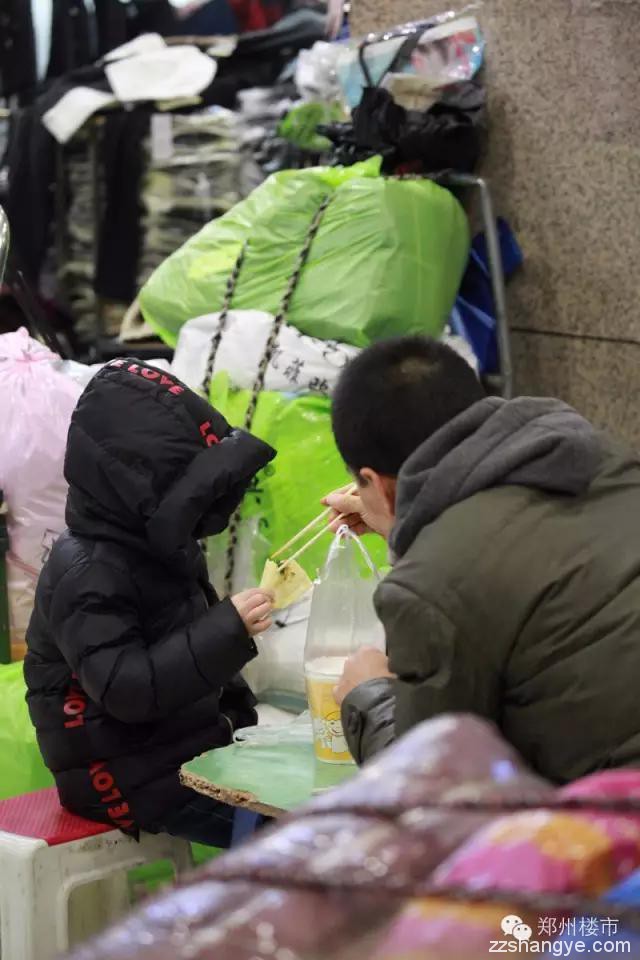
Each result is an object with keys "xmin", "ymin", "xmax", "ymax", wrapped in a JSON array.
[{"xmin": 332, "ymin": 337, "xmax": 485, "ymax": 477}]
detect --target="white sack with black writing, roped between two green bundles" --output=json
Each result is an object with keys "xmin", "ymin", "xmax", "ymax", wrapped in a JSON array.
[{"xmin": 172, "ymin": 310, "xmax": 359, "ymax": 394}]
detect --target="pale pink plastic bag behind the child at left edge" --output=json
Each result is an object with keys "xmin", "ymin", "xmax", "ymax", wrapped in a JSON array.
[{"xmin": 0, "ymin": 328, "xmax": 82, "ymax": 659}]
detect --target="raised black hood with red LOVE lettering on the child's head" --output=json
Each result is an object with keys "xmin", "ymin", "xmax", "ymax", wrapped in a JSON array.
[{"xmin": 64, "ymin": 359, "xmax": 275, "ymax": 559}]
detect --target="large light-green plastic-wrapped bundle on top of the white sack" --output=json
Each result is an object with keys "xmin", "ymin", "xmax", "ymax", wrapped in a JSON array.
[{"xmin": 140, "ymin": 158, "xmax": 469, "ymax": 346}]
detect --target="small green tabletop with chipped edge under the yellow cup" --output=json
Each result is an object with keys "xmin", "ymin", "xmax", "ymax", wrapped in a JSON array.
[{"xmin": 182, "ymin": 743, "xmax": 357, "ymax": 817}]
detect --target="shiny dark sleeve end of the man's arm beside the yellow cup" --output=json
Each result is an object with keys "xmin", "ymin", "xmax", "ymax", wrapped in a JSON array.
[{"xmin": 342, "ymin": 677, "xmax": 396, "ymax": 763}]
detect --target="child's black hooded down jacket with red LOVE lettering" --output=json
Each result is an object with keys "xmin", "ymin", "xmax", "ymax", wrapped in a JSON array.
[{"xmin": 25, "ymin": 360, "xmax": 275, "ymax": 830}]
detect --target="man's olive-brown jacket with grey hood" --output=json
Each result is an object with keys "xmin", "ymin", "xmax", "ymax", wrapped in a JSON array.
[{"xmin": 342, "ymin": 398, "xmax": 640, "ymax": 782}]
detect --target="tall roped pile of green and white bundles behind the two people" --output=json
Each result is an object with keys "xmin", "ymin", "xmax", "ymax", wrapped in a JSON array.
[{"xmin": 138, "ymin": 7, "xmax": 487, "ymax": 709}]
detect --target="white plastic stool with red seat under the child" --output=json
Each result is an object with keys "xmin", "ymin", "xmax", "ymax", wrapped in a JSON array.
[{"xmin": 0, "ymin": 788, "xmax": 192, "ymax": 960}]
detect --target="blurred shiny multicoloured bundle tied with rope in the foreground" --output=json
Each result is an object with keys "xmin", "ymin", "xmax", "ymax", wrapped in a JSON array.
[{"xmin": 66, "ymin": 716, "xmax": 640, "ymax": 960}]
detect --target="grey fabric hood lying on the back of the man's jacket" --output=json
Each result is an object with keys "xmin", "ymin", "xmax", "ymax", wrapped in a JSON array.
[{"xmin": 391, "ymin": 397, "xmax": 602, "ymax": 557}]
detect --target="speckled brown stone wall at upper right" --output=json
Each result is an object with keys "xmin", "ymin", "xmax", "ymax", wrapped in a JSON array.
[{"xmin": 352, "ymin": 0, "xmax": 640, "ymax": 449}]
